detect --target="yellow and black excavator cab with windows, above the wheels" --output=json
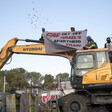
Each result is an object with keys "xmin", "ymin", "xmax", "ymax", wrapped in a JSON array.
[{"xmin": 71, "ymin": 49, "xmax": 112, "ymax": 89}]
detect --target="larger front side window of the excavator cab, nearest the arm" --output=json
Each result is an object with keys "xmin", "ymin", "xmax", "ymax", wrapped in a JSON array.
[{"xmin": 75, "ymin": 52, "xmax": 95, "ymax": 76}]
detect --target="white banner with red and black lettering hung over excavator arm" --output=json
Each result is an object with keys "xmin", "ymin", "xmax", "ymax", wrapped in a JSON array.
[{"xmin": 44, "ymin": 30, "xmax": 87, "ymax": 53}]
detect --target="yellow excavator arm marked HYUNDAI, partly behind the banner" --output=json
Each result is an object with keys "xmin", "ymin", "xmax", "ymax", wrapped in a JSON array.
[{"xmin": 0, "ymin": 38, "xmax": 74, "ymax": 69}]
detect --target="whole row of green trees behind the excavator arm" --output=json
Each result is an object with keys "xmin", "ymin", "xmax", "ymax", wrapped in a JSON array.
[{"xmin": 0, "ymin": 68, "xmax": 70, "ymax": 92}]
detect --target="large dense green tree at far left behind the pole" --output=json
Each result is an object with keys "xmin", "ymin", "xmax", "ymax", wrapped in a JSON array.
[{"xmin": 0, "ymin": 68, "xmax": 29, "ymax": 92}]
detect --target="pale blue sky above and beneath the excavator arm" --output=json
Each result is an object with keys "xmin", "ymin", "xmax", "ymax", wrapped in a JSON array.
[{"xmin": 0, "ymin": 0, "xmax": 112, "ymax": 76}]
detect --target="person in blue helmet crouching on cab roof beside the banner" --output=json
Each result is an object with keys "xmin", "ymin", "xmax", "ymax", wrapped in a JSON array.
[{"xmin": 83, "ymin": 36, "xmax": 98, "ymax": 50}]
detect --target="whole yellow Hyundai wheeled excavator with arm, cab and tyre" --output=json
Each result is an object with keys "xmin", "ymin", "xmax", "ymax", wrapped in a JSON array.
[{"xmin": 0, "ymin": 38, "xmax": 112, "ymax": 112}]
